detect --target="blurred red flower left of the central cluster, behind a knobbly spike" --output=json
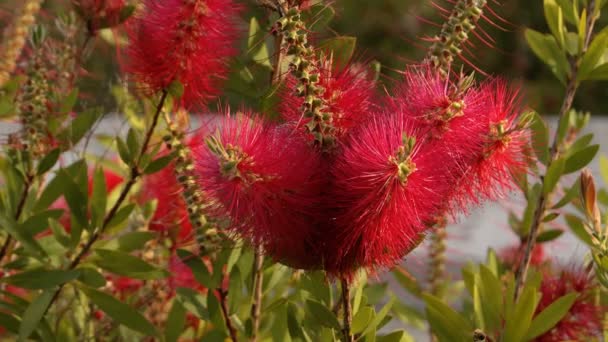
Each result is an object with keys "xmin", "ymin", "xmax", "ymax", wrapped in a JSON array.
[{"xmin": 140, "ymin": 151, "xmax": 193, "ymax": 243}]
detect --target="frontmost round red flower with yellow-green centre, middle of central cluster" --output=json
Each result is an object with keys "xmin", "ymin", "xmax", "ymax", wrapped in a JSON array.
[{"xmin": 324, "ymin": 111, "xmax": 451, "ymax": 275}]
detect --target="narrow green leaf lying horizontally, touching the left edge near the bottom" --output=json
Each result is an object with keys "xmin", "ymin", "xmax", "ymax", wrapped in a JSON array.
[{"xmin": 0, "ymin": 269, "xmax": 80, "ymax": 290}]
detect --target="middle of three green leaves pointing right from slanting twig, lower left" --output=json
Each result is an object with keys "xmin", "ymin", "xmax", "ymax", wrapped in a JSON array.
[{"xmin": 95, "ymin": 249, "xmax": 167, "ymax": 280}]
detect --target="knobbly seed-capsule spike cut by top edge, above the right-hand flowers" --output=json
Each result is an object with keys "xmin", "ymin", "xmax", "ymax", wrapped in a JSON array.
[{"xmin": 428, "ymin": 0, "xmax": 487, "ymax": 77}]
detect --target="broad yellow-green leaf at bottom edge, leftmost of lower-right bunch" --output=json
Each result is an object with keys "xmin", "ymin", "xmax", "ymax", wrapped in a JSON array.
[{"xmin": 423, "ymin": 293, "xmax": 473, "ymax": 342}]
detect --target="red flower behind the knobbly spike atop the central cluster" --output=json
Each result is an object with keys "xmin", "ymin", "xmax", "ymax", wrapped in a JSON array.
[{"xmin": 280, "ymin": 59, "xmax": 375, "ymax": 138}]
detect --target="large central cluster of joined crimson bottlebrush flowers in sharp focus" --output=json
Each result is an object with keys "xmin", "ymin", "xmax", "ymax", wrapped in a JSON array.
[{"xmin": 188, "ymin": 66, "xmax": 530, "ymax": 277}]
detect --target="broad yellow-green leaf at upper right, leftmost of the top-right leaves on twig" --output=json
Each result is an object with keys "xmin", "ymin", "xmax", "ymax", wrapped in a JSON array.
[{"xmin": 525, "ymin": 29, "xmax": 570, "ymax": 83}]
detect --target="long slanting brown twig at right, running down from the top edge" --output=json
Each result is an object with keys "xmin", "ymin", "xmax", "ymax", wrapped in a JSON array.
[{"xmin": 514, "ymin": 0, "xmax": 597, "ymax": 301}]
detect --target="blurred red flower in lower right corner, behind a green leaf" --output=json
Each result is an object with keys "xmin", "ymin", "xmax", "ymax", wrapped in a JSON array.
[{"xmin": 535, "ymin": 268, "xmax": 605, "ymax": 342}]
